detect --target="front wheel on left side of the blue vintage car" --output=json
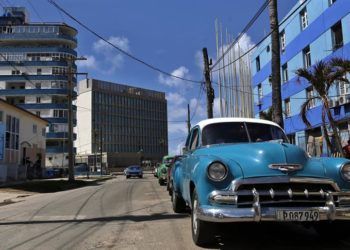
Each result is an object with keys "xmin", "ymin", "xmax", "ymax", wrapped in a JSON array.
[{"xmin": 191, "ymin": 189, "xmax": 214, "ymax": 246}]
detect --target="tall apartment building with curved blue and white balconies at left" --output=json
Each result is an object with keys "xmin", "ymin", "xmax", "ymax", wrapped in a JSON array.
[{"xmin": 0, "ymin": 7, "xmax": 77, "ymax": 167}]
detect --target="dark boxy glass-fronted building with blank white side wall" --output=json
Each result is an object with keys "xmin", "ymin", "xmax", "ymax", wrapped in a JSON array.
[{"xmin": 75, "ymin": 79, "xmax": 168, "ymax": 170}]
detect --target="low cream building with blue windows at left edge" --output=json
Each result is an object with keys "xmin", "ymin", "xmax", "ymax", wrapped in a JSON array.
[{"xmin": 0, "ymin": 99, "xmax": 48, "ymax": 183}]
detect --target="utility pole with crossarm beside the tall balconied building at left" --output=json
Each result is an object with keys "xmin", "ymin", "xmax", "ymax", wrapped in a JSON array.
[{"xmin": 67, "ymin": 57, "xmax": 86, "ymax": 181}]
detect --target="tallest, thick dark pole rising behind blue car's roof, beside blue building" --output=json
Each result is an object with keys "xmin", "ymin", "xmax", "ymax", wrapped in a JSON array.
[{"xmin": 269, "ymin": 0, "xmax": 284, "ymax": 128}]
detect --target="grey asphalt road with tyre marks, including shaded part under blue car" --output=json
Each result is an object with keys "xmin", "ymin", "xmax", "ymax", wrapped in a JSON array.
[{"xmin": 0, "ymin": 175, "xmax": 350, "ymax": 250}]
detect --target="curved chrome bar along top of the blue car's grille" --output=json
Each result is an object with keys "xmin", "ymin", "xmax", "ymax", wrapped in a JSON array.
[{"xmin": 231, "ymin": 176, "xmax": 340, "ymax": 191}]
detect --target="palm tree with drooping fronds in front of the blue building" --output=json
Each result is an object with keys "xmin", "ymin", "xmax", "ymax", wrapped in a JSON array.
[{"xmin": 296, "ymin": 61, "xmax": 349, "ymax": 155}]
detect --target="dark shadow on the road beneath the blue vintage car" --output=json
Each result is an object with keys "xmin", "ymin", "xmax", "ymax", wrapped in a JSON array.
[{"xmin": 209, "ymin": 224, "xmax": 350, "ymax": 250}]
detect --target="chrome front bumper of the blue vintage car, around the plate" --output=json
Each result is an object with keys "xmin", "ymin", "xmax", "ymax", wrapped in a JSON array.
[{"xmin": 197, "ymin": 206, "xmax": 350, "ymax": 222}]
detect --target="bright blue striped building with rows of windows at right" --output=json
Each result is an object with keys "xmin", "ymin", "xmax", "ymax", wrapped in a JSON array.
[{"xmin": 251, "ymin": 0, "xmax": 350, "ymax": 155}]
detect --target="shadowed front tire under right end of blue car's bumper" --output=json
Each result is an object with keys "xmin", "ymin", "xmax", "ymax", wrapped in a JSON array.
[{"xmin": 313, "ymin": 221, "xmax": 350, "ymax": 240}]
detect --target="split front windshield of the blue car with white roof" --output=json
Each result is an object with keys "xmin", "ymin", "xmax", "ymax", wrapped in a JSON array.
[{"xmin": 202, "ymin": 122, "xmax": 287, "ymax": 146}]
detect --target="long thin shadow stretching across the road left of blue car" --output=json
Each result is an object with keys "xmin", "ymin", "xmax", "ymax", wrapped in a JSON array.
[{"xmin": 0, "ymin": 213, "xmax": 188, "ymax": 226}]
